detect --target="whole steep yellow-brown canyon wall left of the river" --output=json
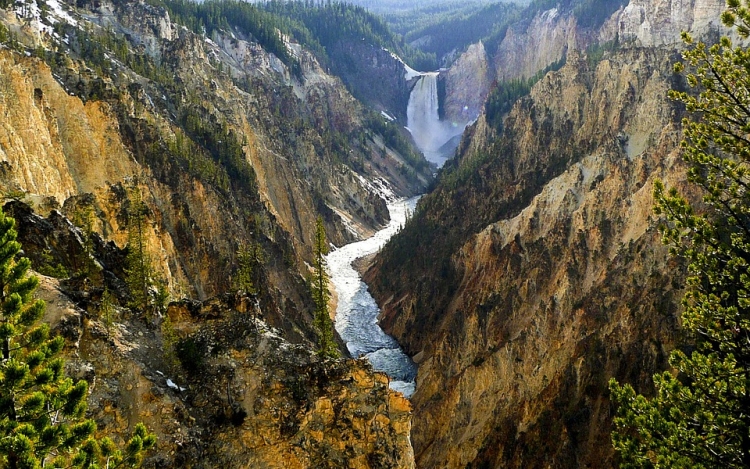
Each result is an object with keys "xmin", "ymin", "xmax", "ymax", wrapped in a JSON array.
[{"xmin": 0, "ymin": 0, "xmax": 431, "ymax": 462}]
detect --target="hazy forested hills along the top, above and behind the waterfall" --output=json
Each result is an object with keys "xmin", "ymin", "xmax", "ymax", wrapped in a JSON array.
[{"xmin": 151, "ymin": 0, "xmax": 625, "ymax": 78}]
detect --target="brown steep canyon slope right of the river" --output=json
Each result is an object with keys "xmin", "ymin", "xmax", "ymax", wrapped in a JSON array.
[{"xmin": 368, "ymin": 43, "xmax": 712, "ymax": 468}]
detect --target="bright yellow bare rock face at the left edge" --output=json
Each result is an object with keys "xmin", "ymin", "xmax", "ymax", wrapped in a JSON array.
[{"xmin": 0, "ymin": 50, "xmax": 135, "ymax": 203}]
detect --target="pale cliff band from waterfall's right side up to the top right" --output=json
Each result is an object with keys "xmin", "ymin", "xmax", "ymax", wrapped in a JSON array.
[{"xmin": 434, "ymin": 0, "xmax": 724, "ymax": 133}]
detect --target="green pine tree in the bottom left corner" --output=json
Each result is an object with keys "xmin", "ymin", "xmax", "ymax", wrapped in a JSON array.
[{"xmin": 0, "ymin": 206, "xmax": 155, "ymax": 469}]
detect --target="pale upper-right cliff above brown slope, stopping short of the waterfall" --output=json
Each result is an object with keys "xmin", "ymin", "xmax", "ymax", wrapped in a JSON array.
[{"xmin": 490, "ymin": 0, "xmax": 725, "ymax": 81}]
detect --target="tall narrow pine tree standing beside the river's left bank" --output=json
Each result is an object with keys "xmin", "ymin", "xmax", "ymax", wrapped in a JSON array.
[{"xmin": 312, "ymin": 217, "xmax": 339, "ymax": 358}]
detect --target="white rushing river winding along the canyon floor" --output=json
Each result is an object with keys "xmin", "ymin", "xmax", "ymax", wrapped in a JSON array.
[{"xmin": 326, "ymin": 197, "xmax": 419, "ymax": 397}]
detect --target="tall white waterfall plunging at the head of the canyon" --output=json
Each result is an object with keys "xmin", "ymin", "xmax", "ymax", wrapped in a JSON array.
[{"xmin": 406, "ymin": 72, "xmax": 466, "ymax": 167}]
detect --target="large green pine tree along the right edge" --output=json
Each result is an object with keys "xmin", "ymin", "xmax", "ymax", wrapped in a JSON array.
[{"xmin": 610, "ymin": 0, "xmax": 750, "ymax": 468}]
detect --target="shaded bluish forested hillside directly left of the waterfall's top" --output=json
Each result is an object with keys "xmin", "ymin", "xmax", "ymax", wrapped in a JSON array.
[{"xmin": 159, "ymin": 0, "xmax": 437, "ymax": 116}]
